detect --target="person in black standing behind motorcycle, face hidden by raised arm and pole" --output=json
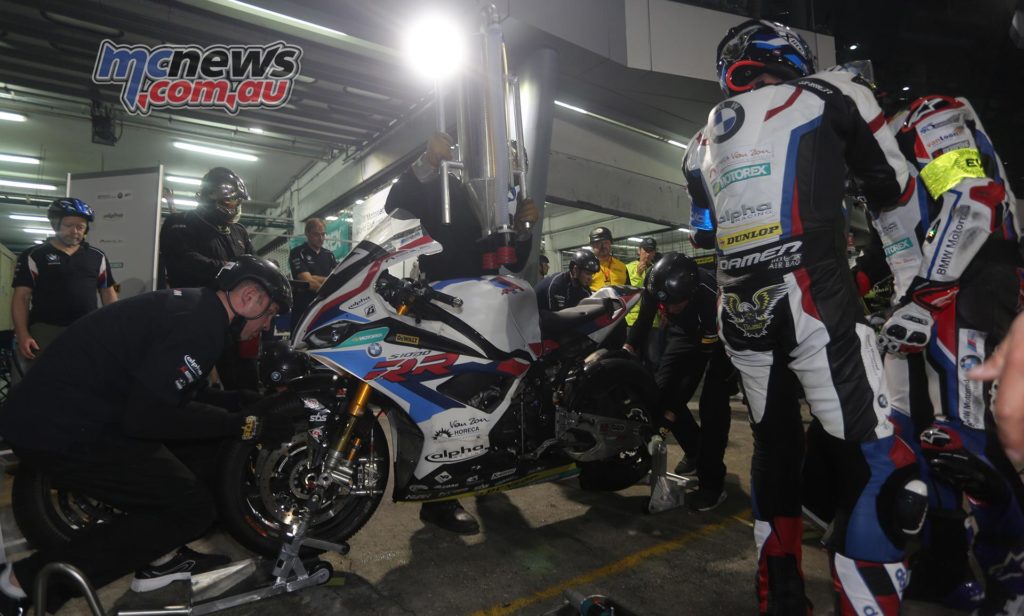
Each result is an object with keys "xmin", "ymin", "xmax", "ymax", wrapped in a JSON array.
[{"xmin": 384, "ymin": 133, "xmax": 538, "ymax": 534}]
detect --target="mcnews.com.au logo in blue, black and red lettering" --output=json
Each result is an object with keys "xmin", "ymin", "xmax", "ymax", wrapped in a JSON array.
[{"xmin": 92, "ymin": 40, "xmax": 302, "ymax": 116}]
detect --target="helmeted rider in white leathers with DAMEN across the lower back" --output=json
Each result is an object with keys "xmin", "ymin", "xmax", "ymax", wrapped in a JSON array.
[{"xmin": 683, "ymin": 20, "xmax": 926, "ymax": 615}]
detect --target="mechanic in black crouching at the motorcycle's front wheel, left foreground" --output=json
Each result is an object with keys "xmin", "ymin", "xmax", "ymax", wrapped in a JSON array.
[{"xmin": 0, "ymin": 256, "xmax": 293, "ymax": 616}]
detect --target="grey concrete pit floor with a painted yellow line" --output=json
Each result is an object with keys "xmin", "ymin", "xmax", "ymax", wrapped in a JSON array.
[{"xmin": 2, "ymin": 404, "xmax": 951, "ymax": 616}]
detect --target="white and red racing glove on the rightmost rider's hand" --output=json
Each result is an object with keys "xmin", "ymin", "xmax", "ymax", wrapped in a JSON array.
[{"xmin": 879, "ymin": 276, "xmax": 959, "ymax": 355}]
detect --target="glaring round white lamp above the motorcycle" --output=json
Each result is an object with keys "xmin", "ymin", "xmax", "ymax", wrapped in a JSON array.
[{"xmin": 402, "ymin": 13, "xmax": 466, "ymax": 82}]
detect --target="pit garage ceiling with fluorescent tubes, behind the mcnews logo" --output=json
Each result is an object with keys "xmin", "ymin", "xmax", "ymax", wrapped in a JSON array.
[{"xmin": 0, "ymin": 0, "xmax": 430, "ymax": 250}]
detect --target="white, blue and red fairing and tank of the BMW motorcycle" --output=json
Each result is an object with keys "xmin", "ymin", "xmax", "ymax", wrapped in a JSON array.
[{"xmin": 293, "ymin": 218, "xmax": 561, "ymax": 500}]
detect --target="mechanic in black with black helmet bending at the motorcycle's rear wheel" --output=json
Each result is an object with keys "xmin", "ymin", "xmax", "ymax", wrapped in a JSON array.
[{"xmin": 624, "ymin": 253, "xmax": 733, "ymax": 512}]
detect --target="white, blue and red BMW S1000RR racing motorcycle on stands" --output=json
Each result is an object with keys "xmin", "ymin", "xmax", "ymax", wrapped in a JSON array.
[{"xmin": 12, "ymin": 218, "xmax": 657, "ymax": 556}]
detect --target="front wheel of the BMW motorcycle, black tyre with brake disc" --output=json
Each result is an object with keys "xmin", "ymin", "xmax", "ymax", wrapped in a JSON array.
[{"xmin": 218, "ymin": 421, "xmax": 391, "ymax": 558}]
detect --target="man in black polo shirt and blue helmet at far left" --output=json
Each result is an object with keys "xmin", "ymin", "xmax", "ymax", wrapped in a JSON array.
[{"xmin": 10, "ymin": 197, "xmax": 118, "ymax": 378}]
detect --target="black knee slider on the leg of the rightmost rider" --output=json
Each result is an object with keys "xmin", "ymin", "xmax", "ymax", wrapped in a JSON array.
[{"xmin": 921, "ymin": 426, "xmax": 1010, "ymax": 503}]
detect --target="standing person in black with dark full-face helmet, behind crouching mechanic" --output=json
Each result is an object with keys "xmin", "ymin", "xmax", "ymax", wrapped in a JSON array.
[{"xmin": 160, "ymin": 167, "xmax": 259, "ymax": 390}]
